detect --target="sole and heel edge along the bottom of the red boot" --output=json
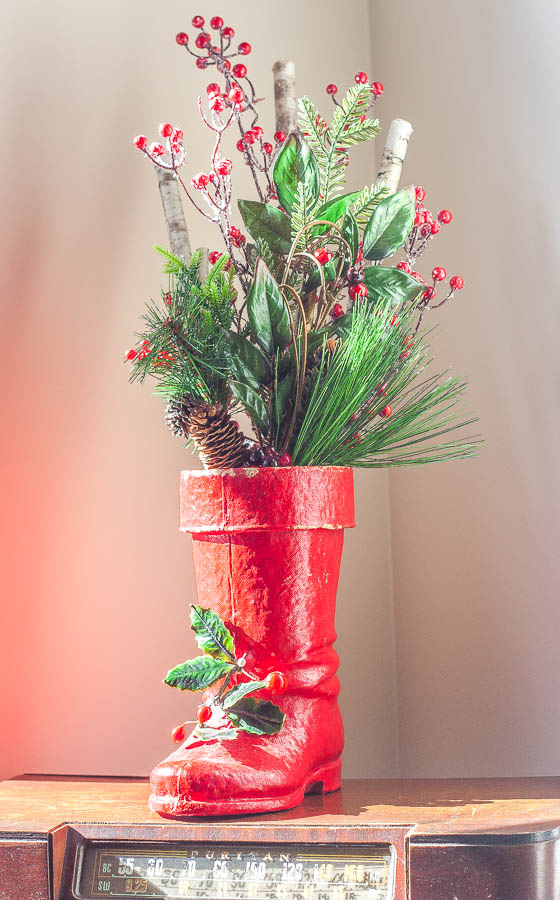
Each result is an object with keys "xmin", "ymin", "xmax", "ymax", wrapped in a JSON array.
[{"xmin": 148, "ymin": 759, "xmax": 342, "ymax": 819}]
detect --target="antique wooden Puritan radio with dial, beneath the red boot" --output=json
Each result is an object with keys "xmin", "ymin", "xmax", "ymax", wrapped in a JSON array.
[{"xmin": 0, "ymin": 776, "xmax": 560, "ymax": 900}]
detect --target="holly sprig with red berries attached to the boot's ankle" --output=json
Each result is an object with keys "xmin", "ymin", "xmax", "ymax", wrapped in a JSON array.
[{"xmin": 164, "ymin": 604, "xmax": 288, "ymax": 743}]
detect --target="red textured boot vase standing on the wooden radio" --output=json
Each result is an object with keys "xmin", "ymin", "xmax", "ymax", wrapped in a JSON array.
[{"xmin": 149, "ymin": 466, "xmax": 355, "ymax": 817}]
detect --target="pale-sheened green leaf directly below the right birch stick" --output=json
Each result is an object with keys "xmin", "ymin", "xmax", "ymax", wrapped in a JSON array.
[{"xmin": 364, "ymin": 187, "xmax": 416, "ymax": 259}]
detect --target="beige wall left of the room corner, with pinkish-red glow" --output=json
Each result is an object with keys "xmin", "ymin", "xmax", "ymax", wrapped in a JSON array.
[{"xmin": 0, "ymin": 0, "xmax": 396, "ymax": 775}]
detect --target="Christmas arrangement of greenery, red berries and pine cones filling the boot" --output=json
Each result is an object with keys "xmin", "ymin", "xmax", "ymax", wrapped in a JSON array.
[{"xmin": 126, "ymin": 16, "xmax": 478, "ymax": 468}]
